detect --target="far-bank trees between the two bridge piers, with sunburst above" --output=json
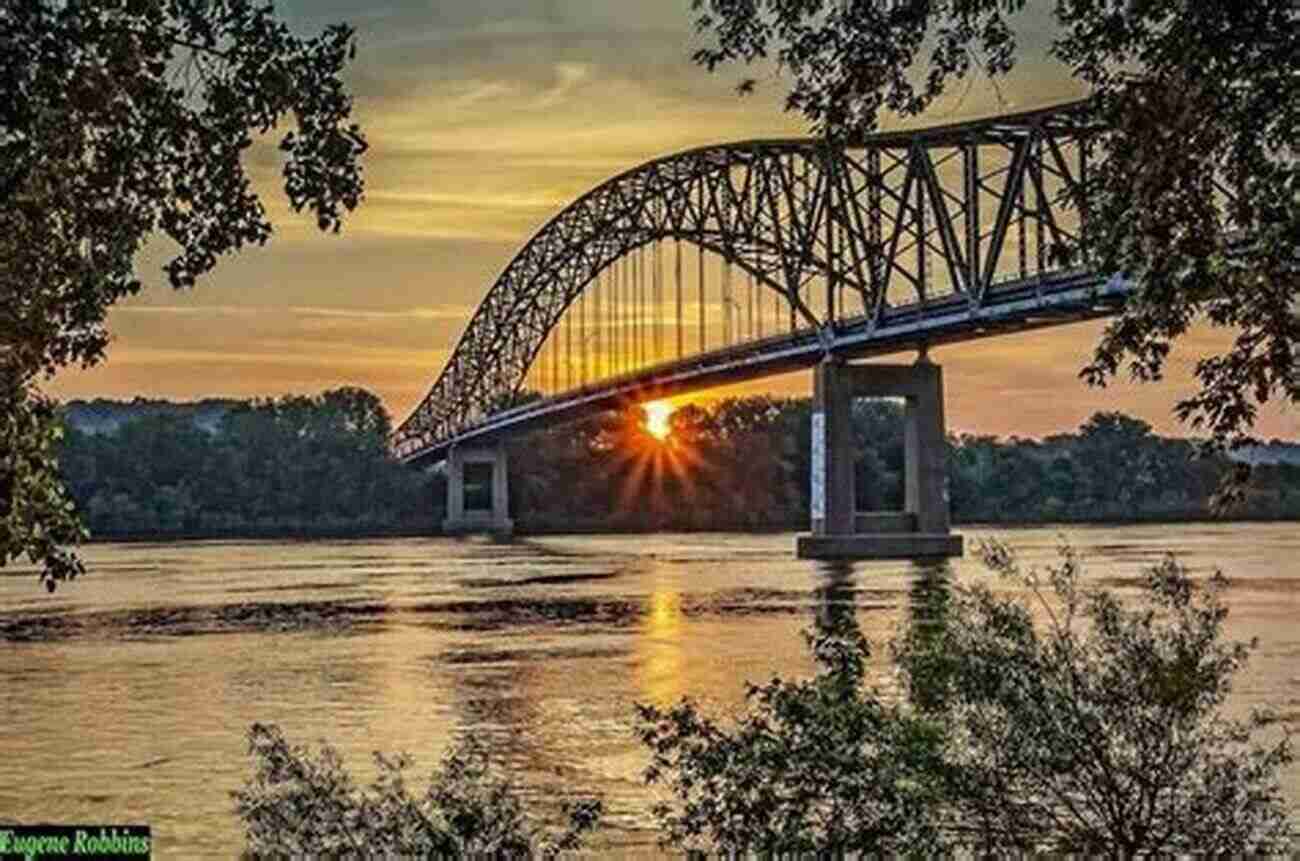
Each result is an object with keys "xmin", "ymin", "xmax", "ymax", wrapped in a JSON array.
[{"xmin": 510, "ymin": 397, "xmax": 902, "ymax": 529}]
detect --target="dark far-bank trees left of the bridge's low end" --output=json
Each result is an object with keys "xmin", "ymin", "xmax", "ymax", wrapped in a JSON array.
[{"xmin": 60, "ymin": 388, "xmax": 431, "ymax": 536}]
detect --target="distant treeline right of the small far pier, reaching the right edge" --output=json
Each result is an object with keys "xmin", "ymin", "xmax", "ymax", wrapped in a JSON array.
[{"xmin": 510, "ymin": 398, "xmax": 1300, "ymax": 529}]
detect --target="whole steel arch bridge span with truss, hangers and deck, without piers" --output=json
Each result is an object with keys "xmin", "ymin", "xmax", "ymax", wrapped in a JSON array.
[{"xmin": 393, "ymin": 97, "xmax": 1130, "ymax": 462}]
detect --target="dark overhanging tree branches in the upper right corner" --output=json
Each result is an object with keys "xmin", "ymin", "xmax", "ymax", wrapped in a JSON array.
[{"xmin": 692, "ymin": 0, "xmax": 1300, "ymax": 445}]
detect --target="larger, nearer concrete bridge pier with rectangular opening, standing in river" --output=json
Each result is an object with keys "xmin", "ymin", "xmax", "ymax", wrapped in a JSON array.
[{"xmin": 796, "ymin": 352, "xmax": 962, "ymax": 559}]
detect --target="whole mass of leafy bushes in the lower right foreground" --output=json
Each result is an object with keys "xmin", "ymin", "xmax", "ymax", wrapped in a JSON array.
[{"xmin": 638, "ymin": 544, "xmax": 1292, "ymax": 856}]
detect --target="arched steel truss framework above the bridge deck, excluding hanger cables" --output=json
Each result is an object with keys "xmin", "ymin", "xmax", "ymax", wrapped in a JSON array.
[{"xmin": 394, "ymin": 103, "xmax": 1097, "ymax": 459}]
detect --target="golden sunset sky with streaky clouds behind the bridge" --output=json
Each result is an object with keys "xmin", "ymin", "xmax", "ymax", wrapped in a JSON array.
[{"xmin": 48, "ymin": 0, "xmax": 1300, "ymax": 440}]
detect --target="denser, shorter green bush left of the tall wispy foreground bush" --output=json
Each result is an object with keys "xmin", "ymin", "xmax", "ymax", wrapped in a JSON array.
[{"xmin": 637, "ymin": 600, "xmax": 943, "ymax": 857}]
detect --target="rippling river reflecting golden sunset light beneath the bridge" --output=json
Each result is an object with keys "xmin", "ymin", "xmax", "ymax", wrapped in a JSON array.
[{"xmin": 0, "ymin": 523, "xmax": 1300, "ymax": 858}]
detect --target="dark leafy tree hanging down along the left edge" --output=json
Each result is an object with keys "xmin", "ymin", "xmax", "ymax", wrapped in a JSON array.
[{"xmin": 0, "ymin": 0, "xmax": 365, "ymax": 588}]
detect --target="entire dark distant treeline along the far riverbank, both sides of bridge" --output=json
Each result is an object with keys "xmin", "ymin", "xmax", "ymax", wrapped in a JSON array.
[{"xmin": 61, "ymin": 389, "xmax": 1300, "ymax": 537}]
